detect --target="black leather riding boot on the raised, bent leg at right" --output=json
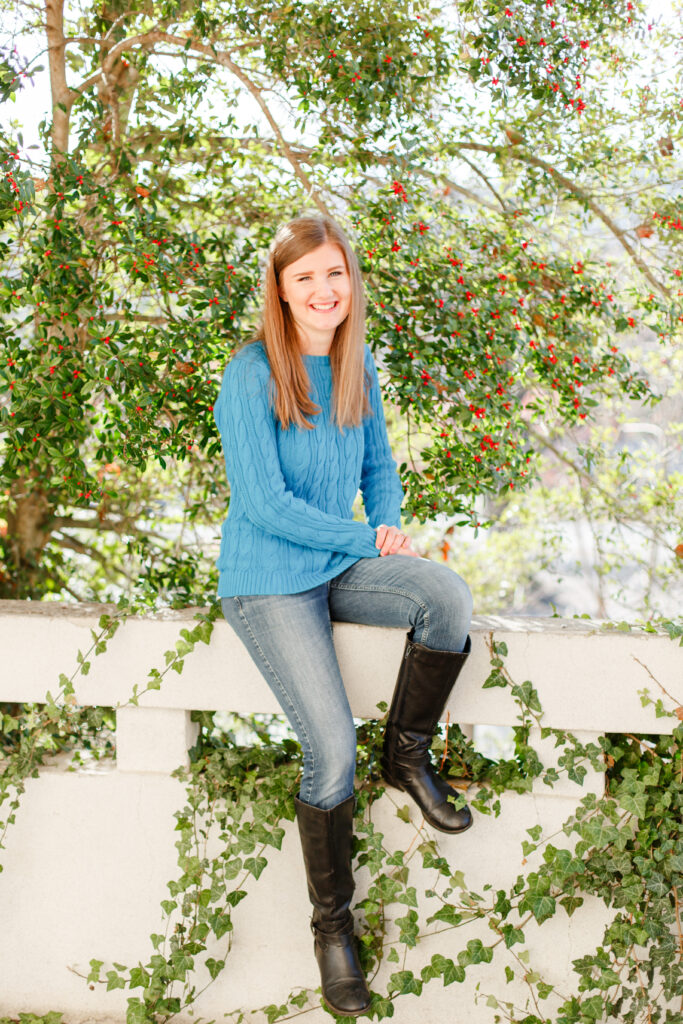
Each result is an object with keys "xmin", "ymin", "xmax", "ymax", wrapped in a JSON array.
[{"xmin": 381, "ymin": 636, "xmax": 472, "ymax": 833}]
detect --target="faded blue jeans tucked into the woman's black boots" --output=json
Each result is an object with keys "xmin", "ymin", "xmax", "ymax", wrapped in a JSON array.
[{"xmin": 221, "ymin": 555, "xmax": 472, "ymax": 809}]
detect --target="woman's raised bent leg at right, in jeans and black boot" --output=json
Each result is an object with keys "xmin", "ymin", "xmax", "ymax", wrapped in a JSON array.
[{"xmin": 330, "ymin": 555, "xmax": 472, "ymax": 834}]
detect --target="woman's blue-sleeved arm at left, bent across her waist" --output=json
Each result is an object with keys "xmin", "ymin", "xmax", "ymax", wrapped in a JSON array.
[{"xmin": 215, "ymin": 358, "xmax": 379, "ymax": 558}]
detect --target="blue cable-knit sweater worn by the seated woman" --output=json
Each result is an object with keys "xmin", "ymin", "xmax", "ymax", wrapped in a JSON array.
[{"xmin": 214, "ymin": 341, "xmax": 403, "ymax": 597}]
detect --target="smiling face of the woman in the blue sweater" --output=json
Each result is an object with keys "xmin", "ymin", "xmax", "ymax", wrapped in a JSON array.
[{"xmin": 278, "ymin": 242, "xmax": 351, "ymax": 355}]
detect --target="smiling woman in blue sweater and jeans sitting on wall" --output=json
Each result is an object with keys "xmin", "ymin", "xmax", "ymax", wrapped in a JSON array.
[{"xmin": 214, "ymin": 215, "xmax": 472, "ymax": 1016}]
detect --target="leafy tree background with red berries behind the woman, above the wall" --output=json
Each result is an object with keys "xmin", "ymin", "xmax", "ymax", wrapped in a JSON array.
[{"xmin": 0, "ymin": 2, "xmax": 681, "ymax": 618}]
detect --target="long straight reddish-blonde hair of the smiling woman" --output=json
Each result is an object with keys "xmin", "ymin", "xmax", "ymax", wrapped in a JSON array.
[{"xmin": 247, "ymin": 214, "xmax": 371, "ymax": 429}]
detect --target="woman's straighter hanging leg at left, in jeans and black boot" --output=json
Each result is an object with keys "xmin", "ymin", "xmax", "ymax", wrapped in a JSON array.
[{"xmin": 221, "ymin": 584, "xmax": 370, "ymax": 1016}]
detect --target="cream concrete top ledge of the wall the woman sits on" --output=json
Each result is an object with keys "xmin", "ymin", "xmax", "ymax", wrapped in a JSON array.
[{"xmin": 0, "ymin": 601, "xmax": 683, "ymax": 732}]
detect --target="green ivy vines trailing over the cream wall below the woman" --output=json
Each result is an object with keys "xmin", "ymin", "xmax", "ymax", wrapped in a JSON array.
[{"xmin": 0, "ymin": 599, "xmax": 683, "ymax": 1024}]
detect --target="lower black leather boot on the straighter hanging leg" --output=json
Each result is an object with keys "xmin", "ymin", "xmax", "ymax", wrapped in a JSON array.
[{"xmin": 294, "ymin": 796, "xmax": 370, "ymax": 1017}]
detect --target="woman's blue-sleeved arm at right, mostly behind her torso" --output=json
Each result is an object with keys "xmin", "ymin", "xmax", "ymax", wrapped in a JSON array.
[{"xmin": 360, "ymin": 345, "xmax": 404, "ymax": 529}]
